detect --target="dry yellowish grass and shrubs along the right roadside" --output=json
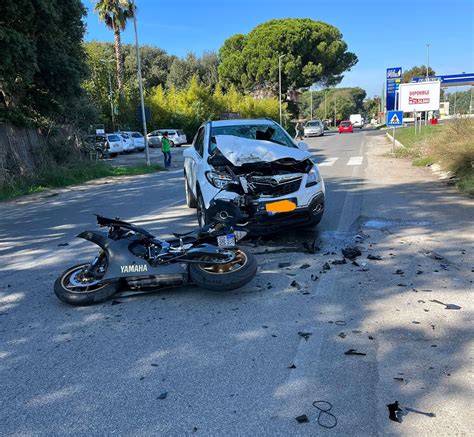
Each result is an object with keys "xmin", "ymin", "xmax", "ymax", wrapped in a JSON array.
[{"xmin": 393, "ymin": 117, "xmax": 474, "ymax": 196}]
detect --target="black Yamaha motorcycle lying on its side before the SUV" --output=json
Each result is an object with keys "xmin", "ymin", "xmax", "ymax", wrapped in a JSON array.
[{"xmin": 54, "ymin": 215, "xmax": 257, "ymax": 305}]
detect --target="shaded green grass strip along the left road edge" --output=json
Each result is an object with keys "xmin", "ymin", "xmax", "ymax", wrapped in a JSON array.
[{"xmin": 0, "ymin": 161, "xmax": 163, "ymax": 200}]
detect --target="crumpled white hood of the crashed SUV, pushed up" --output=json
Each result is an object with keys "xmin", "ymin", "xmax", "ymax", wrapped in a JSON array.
[{"xmin": 215, "ymin": 135, "xmax": 311, "ymax": 166}]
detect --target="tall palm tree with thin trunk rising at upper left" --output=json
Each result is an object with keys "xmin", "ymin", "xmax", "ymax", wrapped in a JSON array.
[{"xmin": 94, "ymin": 0, "xmax": 135, "ymax": 95}]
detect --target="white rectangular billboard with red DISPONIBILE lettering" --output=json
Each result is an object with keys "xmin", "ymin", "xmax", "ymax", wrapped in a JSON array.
[{"xmin": 398, "ymin": 81, "xmax": 441, "ymax": 112}]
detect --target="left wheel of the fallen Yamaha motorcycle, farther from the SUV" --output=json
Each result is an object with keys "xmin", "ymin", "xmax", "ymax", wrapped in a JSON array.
[{"xmin": 54, "ymin": 263, "xmax": 120, "ymax": 306}]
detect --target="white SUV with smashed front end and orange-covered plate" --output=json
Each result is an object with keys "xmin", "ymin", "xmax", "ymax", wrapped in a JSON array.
[{"xmin": 183, "ymin": 119, "xmax": 325, "ymax": 235}]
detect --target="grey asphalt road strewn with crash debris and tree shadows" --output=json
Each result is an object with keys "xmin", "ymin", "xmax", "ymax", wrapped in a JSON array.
[{"xmin": 0, "ymin": 127, "xmax": 474, "ymax": 436}]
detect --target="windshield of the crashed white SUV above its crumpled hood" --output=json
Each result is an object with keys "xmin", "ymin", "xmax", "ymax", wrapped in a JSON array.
[{"xmin": 209, "ymin": 124, "xmax": 296, "ymax": 154}]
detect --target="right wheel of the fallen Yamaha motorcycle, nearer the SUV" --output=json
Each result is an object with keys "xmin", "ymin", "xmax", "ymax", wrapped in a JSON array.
[{"xmin": 189, "ymin": 248, "xmax": 257, "ymax": 291}]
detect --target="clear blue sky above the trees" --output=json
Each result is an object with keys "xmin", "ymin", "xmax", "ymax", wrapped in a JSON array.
[{"xmin": 83, "ymin": 0, "xmax": 474, "ymax": 96}]
